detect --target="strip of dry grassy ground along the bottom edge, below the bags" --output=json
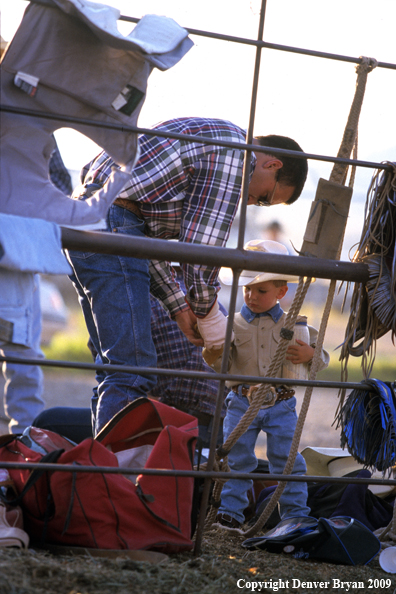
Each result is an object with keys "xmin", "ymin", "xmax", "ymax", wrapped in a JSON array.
[{"xmin": 0, "ymin": 529, "xmax": 396, "ymax": 594}]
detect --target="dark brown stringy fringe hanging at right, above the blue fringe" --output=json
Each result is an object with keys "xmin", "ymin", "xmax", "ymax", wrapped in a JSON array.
[{"xmin": 340, "ymin": 163, "xmax": 396, "ymax": 386}]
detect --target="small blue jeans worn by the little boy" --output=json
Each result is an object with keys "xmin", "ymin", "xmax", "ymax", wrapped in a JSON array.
[{"xmin": 219, "ymin": 392, "xmax": 310, "ymax": 523}]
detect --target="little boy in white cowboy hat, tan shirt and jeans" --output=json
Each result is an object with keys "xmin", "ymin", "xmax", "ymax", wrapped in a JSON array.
[{"xmin": 203, "ymin": 240, "xmax": 329, "ymax": 528}]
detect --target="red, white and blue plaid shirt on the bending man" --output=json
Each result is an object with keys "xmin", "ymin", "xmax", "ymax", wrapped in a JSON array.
[{"xmin": 81, "ymin": 118, "xmax": 256, "ymax": 317}]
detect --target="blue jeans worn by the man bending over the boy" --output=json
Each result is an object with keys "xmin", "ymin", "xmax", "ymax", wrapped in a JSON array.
[{"xmin": 69, "ymin": 206, "xmax": 157, "ymax": 435}]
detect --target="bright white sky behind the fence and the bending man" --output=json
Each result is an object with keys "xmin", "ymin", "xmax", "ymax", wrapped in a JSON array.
[{"xmin": 0, "ymin": 0, "xmax": 396, "ymax": 259}]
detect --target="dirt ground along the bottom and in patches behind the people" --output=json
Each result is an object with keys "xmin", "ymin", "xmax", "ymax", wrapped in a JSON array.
[{"xmin": 0, "ymin": 371, "xmax": 396, "ymax": 594}]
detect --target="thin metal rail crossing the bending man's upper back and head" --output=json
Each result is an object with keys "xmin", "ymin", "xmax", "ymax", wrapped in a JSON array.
[{"xmin": 0, "ymin": 104, "xmax": 391, "ymax": 169}]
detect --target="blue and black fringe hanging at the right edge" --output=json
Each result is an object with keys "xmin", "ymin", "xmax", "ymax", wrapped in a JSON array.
[{"xmin": 338, "ymin": 379, "xmax": 396, "ymax": 471}]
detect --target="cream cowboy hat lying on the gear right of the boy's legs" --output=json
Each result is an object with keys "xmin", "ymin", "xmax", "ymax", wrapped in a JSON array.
[{"xmin": 301, "ymin": 446, "xmax": 395, "ymax": 497}]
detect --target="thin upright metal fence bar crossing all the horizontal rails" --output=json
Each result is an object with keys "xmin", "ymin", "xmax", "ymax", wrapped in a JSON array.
[{"xmin": 194, "ymin": 0, "xmax": 267, "ymax": 555}]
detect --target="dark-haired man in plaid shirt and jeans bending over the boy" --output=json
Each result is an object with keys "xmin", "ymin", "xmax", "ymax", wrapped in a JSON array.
[{"xmin": 69, "ymin": 118, "xmax": 307, "ymax": 432}]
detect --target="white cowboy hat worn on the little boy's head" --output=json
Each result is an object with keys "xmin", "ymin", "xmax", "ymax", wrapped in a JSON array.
[{"xmin": 219, "ymin": 239, "xmax": 298, "ymax": 286}]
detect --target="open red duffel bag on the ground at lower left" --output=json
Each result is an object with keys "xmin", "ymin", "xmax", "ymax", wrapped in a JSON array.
[{"xmin": 0, "ymin": 398, "xmax": 198, "ymax": 553}]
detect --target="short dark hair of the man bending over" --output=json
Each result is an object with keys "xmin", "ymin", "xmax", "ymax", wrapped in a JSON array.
[{"xmin": 255, "ymin": 134, "xmax": 308, "ymax": 204}]
